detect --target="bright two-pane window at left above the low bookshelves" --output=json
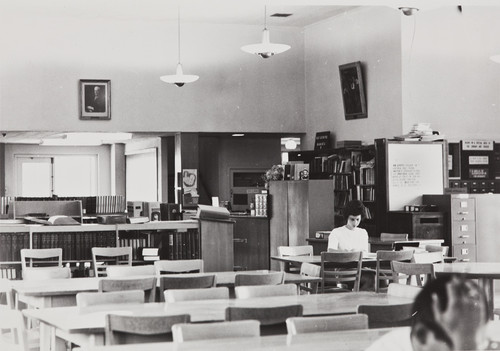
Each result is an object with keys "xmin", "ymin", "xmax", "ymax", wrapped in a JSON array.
[{"xmin": 16, "ymin": 155, "xmax": 98, "ymax": 197}]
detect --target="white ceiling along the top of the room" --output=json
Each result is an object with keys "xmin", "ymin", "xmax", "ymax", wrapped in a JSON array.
[{"xmin": 6, "ymin": 0, "xmax": 500, "ymax": 27}]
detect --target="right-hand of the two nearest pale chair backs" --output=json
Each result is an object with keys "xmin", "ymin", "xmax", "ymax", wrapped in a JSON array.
[{"xmin": 286, "ymin": 314, "xmax": 368, "ymax": 335}]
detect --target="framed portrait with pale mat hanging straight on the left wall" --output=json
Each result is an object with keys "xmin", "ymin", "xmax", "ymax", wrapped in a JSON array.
[{"xmin": 79, "ymin": 79, "xmax": 111, "ymax": 120}]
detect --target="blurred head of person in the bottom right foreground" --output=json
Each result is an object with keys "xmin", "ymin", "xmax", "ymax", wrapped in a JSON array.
[{"xmin": 411, "ymin": 276, "xmax": 489, "ymax": 351}]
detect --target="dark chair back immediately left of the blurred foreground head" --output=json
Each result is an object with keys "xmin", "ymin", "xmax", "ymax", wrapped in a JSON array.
[{"xmin": 358, "ymin": 303, "xmax": 413, "ymax": 328}]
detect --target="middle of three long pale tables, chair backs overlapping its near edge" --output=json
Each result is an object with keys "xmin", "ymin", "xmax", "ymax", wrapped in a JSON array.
[{"xmin": 23, "ymin": 292, "xmax": 413, "ymax": 351}]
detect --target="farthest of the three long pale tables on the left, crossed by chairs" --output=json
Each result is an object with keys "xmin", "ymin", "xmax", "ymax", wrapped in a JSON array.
[{"xmin": 10, "ymin": 271, "xmax": 321, "ymax": 308}]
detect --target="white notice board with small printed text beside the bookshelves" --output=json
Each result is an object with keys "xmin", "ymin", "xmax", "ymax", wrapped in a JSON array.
[{"xmin": 387, "ymin": 143, "xmax": 445, "ymax": 211}]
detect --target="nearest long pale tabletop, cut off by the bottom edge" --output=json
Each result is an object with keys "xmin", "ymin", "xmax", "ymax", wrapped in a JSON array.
[{"xmin": 88, "ymin": 328, "xmax": 392, "ymax": 351}]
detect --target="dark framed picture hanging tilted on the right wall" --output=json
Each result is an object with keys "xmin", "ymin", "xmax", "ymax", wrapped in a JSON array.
[{"xmin": 339, "ymin": 61, "xmax": 368, "ymax": 120}]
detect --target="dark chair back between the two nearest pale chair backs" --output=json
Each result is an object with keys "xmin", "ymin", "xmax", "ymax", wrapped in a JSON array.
[{"xmin": 226, "ymin": 305, "xmax": 303, "ymax": 336}]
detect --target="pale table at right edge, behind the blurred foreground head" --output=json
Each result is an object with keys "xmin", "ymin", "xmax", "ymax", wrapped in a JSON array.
[{"xmin": 434, "ymin": 262, "xmax": 500, "ymax": 319}]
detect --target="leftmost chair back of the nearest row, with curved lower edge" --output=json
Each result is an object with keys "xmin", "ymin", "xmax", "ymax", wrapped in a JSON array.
[{"xmin": 104, "ymin": 314, "xmax": 191, "ymax": 345}]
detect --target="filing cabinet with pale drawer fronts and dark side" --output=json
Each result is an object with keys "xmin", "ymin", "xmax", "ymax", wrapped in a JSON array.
[{"xmin": 422, "ymin": 194, "xmax": 477, "ymax": 261}]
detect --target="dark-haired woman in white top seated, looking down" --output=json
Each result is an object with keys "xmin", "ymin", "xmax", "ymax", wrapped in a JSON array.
[{"xmin": 328, "ymin": 200, "xmax": 368, "ymax": 252}]
